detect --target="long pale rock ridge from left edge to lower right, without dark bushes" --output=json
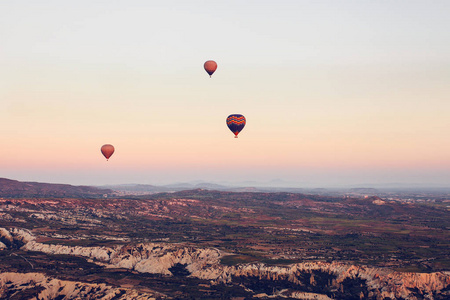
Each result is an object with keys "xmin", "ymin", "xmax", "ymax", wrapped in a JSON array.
[{"xmin": 0, "ymin": 230, "xmax": 450, "ymax": 299}]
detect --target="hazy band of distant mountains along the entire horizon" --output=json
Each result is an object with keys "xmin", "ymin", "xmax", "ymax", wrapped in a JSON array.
[{"xmin": 0, "ymin": 178, "xmax": 450, "ymax": 198}]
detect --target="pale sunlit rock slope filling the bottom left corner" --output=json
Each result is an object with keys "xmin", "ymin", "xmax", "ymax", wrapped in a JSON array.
[{"xmin": 0, "ymin": 273, "xmax": 156, "ymax": 300}]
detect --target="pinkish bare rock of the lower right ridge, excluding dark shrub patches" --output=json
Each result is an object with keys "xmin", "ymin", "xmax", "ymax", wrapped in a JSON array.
[{"xmin": 207, "ymin": 262, "xmax": 450, "ymax": 299}]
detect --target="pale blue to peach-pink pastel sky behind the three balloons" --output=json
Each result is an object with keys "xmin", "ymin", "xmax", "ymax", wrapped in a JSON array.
[{"xmin": 0, "ymin": 0, "xmax": 450, "ymax": 187}]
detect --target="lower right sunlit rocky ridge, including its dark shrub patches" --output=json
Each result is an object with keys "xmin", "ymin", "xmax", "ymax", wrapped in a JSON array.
[{"xmin": 203, "ymin": 262, "xmax": 450, "ymax": 299}]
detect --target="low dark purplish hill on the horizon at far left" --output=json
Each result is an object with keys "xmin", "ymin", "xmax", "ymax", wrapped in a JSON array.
[{"xmin": 0, "ymin": 178, "xmax": 113, "ymax": 198}]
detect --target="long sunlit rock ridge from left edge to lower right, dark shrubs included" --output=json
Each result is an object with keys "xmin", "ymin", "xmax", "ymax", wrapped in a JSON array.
[{"xmin": 0, "ymin": 229, "xmax": 450, "ymax": 299}]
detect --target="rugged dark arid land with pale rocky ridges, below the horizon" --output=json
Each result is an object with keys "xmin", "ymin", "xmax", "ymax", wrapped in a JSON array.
[{"xmin": 0, "ymin": 179, "xmax": 450, "ymax": 300}]
